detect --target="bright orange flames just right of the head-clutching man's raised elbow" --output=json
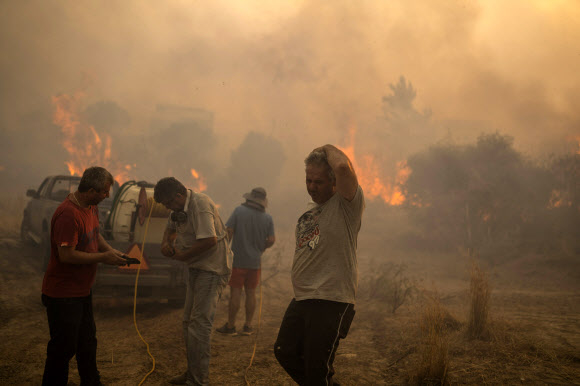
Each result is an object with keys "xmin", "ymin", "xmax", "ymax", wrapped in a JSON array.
[{"xmin": 340, "ymin": 127, "xmax": 411, "ymax": 205}]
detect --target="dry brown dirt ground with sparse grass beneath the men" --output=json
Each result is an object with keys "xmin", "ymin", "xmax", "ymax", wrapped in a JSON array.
[{"xmin": 0, "ymin": 229, "xmax": 580, "ymax": 385}]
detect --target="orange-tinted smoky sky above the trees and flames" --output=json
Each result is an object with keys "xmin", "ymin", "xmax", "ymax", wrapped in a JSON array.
[{"xmin": 0, "ymin": 0, "xmax": 580, "ymax": 199}]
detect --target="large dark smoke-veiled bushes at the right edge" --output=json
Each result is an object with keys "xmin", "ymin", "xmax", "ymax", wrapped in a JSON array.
[{"xmin": 403, "ymin": 133, "xmax": 580, "ymax": 260}]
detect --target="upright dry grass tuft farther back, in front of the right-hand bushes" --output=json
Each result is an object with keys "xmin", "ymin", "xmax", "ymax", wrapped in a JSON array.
[{"xmin": 467, "ymin": 262, "xmax": 491, "ymax": 339}]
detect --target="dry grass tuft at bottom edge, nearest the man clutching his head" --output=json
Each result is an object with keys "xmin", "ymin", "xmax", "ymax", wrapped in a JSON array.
[{"xmin": 415, "ymin": 298, "xmax": 449, "ymax": 385}]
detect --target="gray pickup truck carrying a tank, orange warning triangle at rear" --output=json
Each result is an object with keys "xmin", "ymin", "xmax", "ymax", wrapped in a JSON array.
[{"xmin": 20, "ymin": 175, "xmax": 186, "ymax": 305}]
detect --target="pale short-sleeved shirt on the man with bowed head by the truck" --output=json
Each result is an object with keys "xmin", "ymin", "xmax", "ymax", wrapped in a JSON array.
[{"xmin": 167, "ymin": 190, "xmax": 233, "ymax": 275}]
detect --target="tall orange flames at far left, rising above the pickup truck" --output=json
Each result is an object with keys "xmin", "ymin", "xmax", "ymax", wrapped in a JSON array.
[{"xmin": 52, "ymin": 92, "xmax": 136, "ymax": 184}]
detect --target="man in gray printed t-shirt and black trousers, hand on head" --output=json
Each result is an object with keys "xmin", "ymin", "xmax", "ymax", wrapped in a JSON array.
[{"xmin": 274, "ymin": 145, "xmax": 365, "ymax": 385}]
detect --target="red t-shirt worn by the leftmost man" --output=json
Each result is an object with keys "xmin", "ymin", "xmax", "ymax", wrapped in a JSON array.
[{"xmin": 42, "ymin": 198, "xmax": 99, "ymax": 298}]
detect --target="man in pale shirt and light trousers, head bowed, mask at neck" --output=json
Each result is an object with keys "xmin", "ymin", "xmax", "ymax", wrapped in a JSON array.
[{"xmin": 154, "ymin": 177, "xmax": 233, "ymax": 385}]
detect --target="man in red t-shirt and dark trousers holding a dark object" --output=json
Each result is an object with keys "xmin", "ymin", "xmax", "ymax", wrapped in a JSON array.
[{"xmin": 42, "ymin": 166, "xmax": 126, "ymax": 385}]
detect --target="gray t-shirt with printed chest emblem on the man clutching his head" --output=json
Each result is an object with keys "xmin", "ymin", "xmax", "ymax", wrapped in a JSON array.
[{"xmin": 292, "ymin": 186, "xmax": 365, "ymax": 304}]
